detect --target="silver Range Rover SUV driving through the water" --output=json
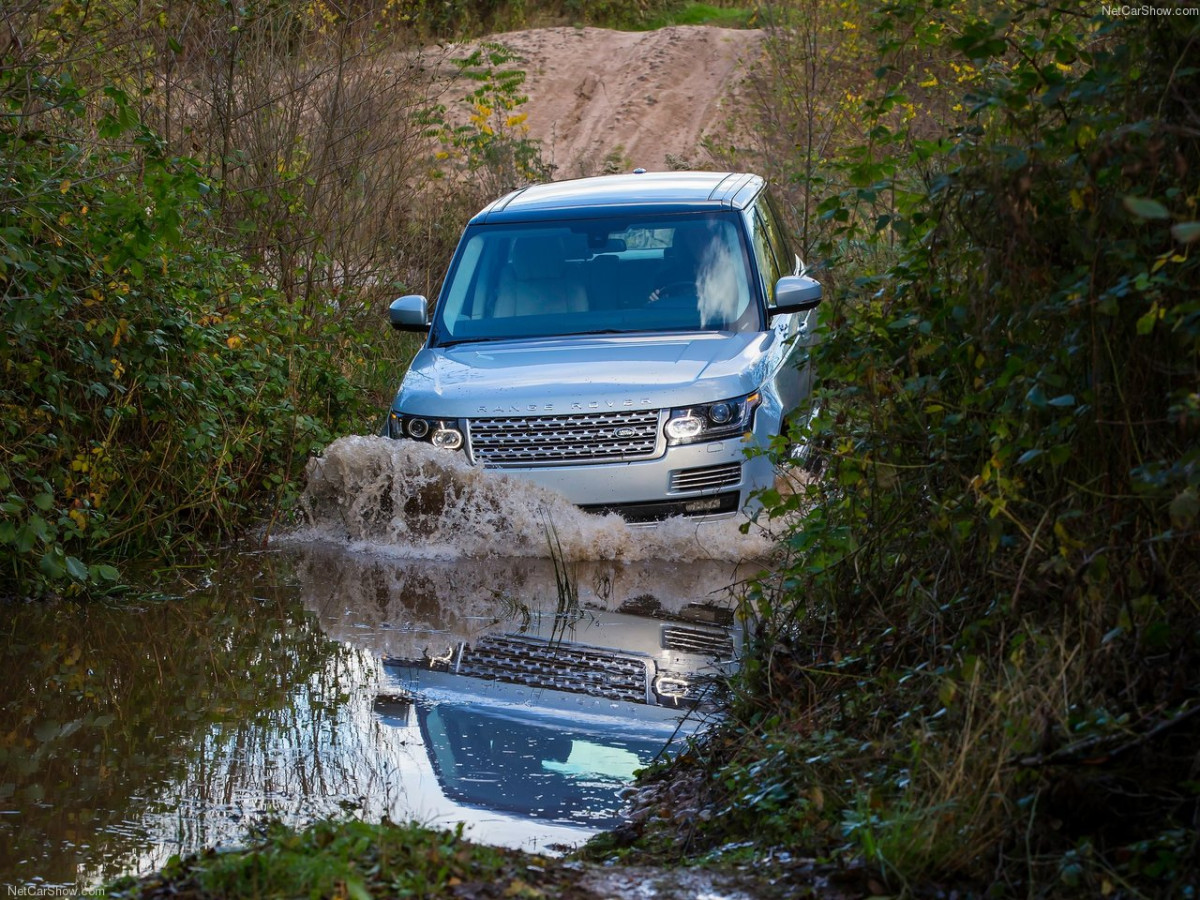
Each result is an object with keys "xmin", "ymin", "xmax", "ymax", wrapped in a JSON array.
[{"xmin": 385, "ymin": 172, "xmax": 821, "ymax": 521}]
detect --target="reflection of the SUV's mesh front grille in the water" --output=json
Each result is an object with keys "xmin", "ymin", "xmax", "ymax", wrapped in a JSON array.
[{"xmin": 454, "ymin": 635, "xmax": 650, "ymax": 703}]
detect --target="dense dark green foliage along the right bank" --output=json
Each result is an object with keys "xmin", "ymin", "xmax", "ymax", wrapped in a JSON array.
[{"xmin": 657, "ymin": 0, "xmax": 1200, "ymax": 895}]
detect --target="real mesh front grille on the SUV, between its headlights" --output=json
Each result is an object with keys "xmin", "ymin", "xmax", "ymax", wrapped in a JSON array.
[{"xmin": 467, "ymin": 409, "xmax": 659, "ymax": 467}]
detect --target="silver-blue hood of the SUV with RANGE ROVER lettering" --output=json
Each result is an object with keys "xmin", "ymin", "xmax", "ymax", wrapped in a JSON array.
[{"xmin": 396, "ymin": 331, "xmax": 778, "ymax": 418}]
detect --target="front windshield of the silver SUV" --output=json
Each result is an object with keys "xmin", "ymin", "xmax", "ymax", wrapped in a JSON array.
[{"xmin": 433, "ymin": 214, "xmax": 762, "ymax": 343}]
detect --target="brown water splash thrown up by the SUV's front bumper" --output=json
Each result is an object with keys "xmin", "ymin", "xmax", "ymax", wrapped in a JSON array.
[{"xmin": 290, "ymin": 436, "xmax": 773, "ymax": 562}]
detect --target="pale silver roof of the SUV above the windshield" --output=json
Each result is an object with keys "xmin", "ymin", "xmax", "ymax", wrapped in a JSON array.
[{"xmin": 470, "ymin": 172, "xmax": 763, "ymax": 224}]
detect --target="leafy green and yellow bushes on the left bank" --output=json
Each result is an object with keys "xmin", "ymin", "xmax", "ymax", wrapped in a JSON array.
[{"xmin": 0, "ymin": 19, "xmax": 367, "ymax": 593}]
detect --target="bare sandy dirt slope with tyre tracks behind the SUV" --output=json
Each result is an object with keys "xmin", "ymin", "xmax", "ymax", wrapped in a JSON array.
[{"xmin": 456, "ymin": 25, "xmax": 763, "ymax": 179}]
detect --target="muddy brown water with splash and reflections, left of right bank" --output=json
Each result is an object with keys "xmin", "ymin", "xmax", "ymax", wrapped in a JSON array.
[{"xmin": 0, "ymin": 438, "xmax": 770, "ymax": 890}]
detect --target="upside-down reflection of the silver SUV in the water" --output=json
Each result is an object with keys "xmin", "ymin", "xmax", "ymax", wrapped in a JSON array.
[{"xmin": 384, "ymin": 607, "xmax": 738, "ymax": 827}]
